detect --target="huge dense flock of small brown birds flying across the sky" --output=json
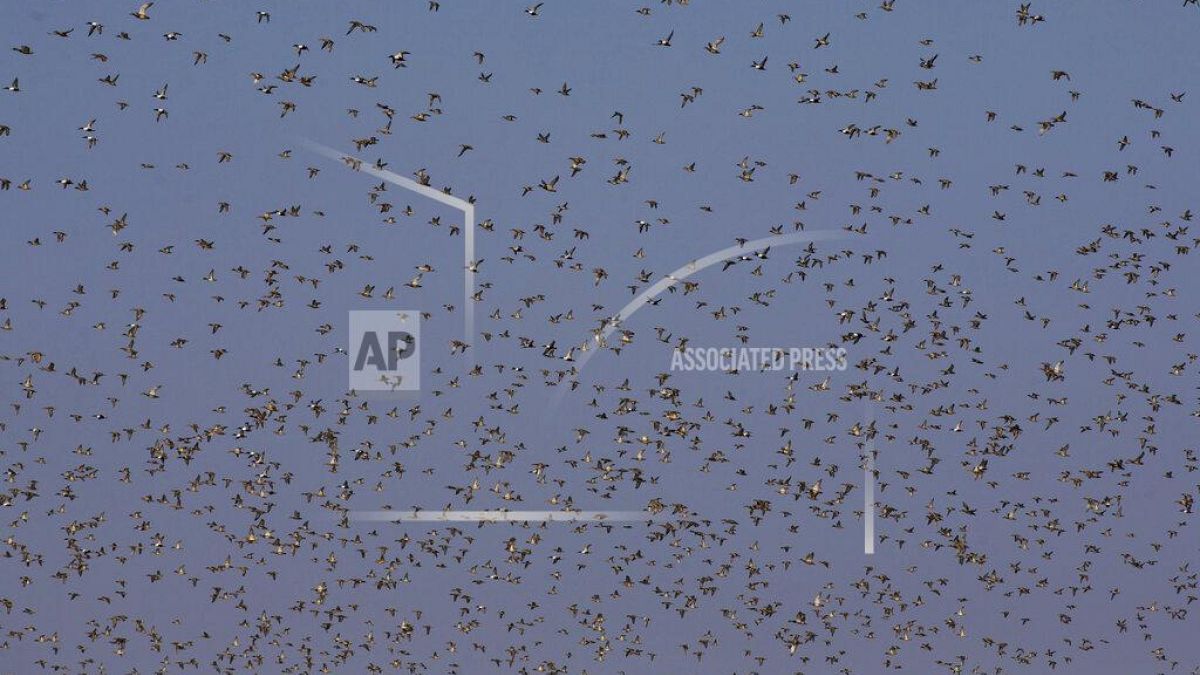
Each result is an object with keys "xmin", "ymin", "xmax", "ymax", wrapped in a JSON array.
[{"xmin": 0, "ymin": 0, "xmax": 1200, "ymax": 675}]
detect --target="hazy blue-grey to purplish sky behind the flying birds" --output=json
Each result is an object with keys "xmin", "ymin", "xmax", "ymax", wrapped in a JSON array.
[{"xmin": 0, "ymin": 0, "xmax": 1200, "ymax": 674}]
